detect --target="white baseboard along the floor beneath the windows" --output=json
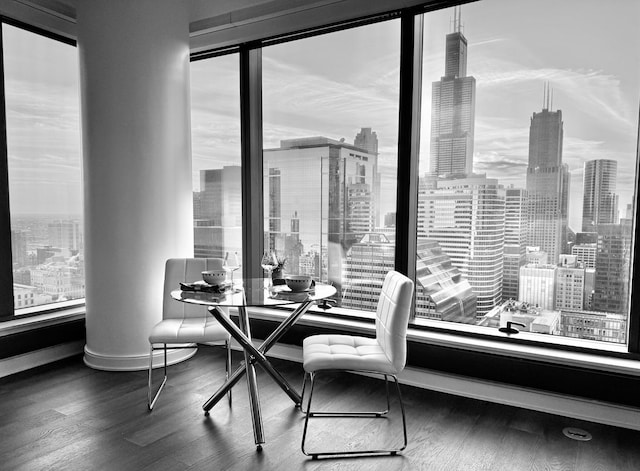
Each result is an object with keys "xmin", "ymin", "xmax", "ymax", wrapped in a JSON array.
[{"xmin": 5, "ymin": 341, "xmax": 640, "ymax": 430}]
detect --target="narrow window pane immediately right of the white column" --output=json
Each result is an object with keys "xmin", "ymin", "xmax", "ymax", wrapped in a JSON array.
[{"xmin": 191, "ymin": 53, "xmax": 242, "ymax": 273}]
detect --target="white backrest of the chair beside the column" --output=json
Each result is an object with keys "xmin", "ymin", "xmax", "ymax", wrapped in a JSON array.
[{"xmin": 162, "ymin": 258, "xmax": 222, "ymax": 319}]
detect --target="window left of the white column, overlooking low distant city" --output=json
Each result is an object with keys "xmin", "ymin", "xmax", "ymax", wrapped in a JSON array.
[{"xmin": 2, "ymin": 19, "xmax": 84, "ymax": 318}]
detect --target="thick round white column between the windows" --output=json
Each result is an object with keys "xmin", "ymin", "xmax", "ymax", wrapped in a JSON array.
[{"xmin": 77, "ymin": 0, "xmax": 194, "ymax": 370}]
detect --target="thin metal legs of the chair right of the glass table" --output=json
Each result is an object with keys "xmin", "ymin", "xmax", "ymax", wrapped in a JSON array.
[{"xmin": 301, "ymin": 372, "xmax": 407, "ymax": 460}]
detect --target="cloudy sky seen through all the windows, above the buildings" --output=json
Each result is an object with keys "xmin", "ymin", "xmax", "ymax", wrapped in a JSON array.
[{"xmin": 4, "ymin": 0, "xmax": 640, "ymax": 230}]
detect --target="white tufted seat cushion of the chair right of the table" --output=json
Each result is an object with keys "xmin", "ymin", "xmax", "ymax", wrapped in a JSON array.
[{"xmin": 302, "ymin": 335, "xmax": 398, "ymax": 374}]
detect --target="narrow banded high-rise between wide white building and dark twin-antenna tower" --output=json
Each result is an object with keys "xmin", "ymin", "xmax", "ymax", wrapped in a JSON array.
[{"xmin": 502, "ymin": 188, "xmax": 528, "ymax": 300}]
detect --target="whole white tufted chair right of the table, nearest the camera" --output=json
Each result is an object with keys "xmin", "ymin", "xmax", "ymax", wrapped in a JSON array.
[{"xmin": 302, "ymin": 271, "xmax": 413, "ymax": 459}]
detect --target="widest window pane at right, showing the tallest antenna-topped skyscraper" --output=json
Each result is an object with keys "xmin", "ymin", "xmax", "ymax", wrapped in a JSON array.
[{"xmin": 415, "ymin": 0, "xmax": 640, "ymax": 344}]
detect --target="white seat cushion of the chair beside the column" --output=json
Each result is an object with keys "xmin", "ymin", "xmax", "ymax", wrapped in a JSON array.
[{"xmin": 149, "ymin": 315, "xmax": 231, "ymax": 343}]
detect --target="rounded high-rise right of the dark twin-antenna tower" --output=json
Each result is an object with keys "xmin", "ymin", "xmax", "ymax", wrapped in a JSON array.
[{"xmin": 582, "ymin": 159, "xmax": 618, "ymax": 232}]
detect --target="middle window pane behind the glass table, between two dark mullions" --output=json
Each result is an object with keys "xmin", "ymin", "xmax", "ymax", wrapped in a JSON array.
[{"xmin": 262, "ymin": 19, "xmax": 400, "ymax": 311}]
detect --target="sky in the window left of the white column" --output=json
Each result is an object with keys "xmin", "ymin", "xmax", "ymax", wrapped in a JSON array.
[{"xmin": 2, "ymin": 24, "xmax": 83, "ymax": 216}]
